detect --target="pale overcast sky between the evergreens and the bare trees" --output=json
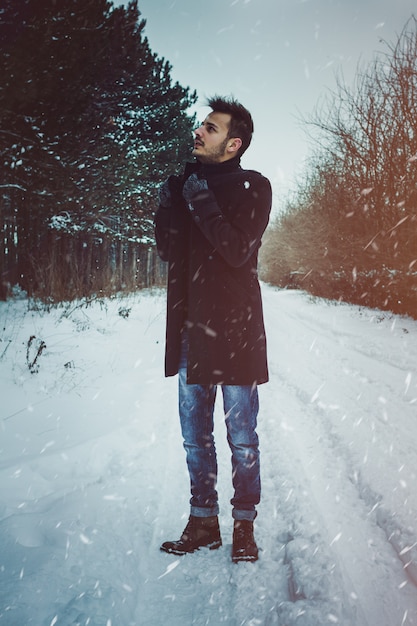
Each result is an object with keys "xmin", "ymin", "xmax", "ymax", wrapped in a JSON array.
[{"xmin": 115, "ymin": 0, "xmax": 417, "ymax": 210}]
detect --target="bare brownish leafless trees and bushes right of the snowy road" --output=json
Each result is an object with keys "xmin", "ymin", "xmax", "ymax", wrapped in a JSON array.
[{"xmin": 261, "ymin": 17, "xmax": 417, "ymax": 318}]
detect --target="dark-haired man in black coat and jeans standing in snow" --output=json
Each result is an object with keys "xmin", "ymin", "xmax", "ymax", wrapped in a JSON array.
[{"xmin": 155, "ymin": 97, "xmax": 271, "ymax": 562}]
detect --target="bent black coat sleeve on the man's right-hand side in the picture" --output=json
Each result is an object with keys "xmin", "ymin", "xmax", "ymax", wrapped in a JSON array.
[{"xmin": 189, "ymin": 175, "xmax": 272, "ymax": 267}]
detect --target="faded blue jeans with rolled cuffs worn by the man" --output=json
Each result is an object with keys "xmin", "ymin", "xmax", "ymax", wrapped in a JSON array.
[{"xmin": 178, "ymin": 334, "xmax": 261, "ymax": 521}]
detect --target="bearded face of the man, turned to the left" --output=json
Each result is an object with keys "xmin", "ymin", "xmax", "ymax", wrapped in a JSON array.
[{"xmin": 193, "ymin": 112, "xmax": 242, "ymax": 163}]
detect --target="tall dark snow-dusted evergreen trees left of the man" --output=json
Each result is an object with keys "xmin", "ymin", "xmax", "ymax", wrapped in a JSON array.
[{"xmin": 0, "ymin": 0, "xmax": 196, "ymax": 301}]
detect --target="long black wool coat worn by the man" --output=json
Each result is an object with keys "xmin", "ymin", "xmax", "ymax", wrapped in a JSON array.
[{"xmin": 155, "ymin": 158, "xmax": 272, "ymax": 385}]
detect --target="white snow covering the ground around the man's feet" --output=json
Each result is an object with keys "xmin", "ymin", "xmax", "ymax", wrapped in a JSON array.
[{"xmin": 0, "ymin": 285, "xmax": 417, "ymax": 626}]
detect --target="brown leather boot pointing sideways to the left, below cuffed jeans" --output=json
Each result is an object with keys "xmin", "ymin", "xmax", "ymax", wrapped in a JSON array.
[{"xmin": 161, "ymin": 515, "xmax": 222, "ymax": 556}]
